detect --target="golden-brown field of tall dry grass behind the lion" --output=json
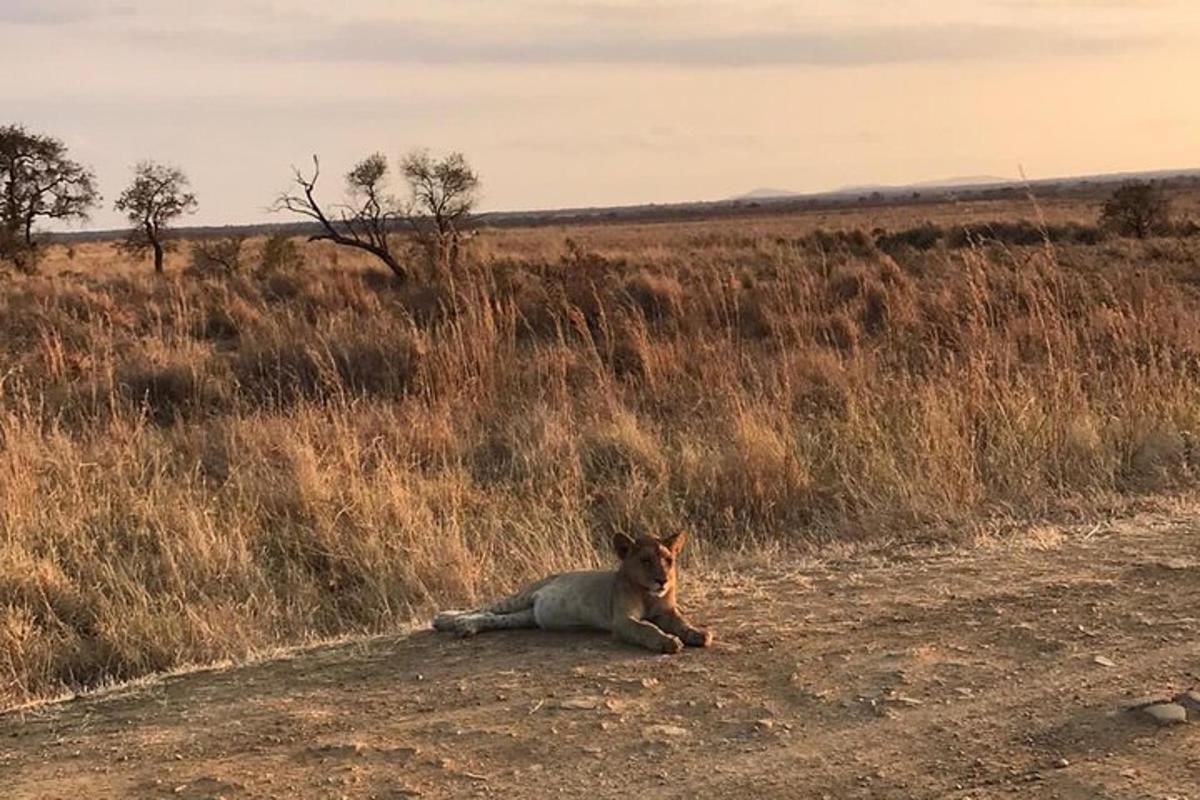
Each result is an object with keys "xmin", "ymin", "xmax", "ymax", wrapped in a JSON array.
[{"xmin": 0, "ymin": 190, "xmax": 1200, "ymax": 706}]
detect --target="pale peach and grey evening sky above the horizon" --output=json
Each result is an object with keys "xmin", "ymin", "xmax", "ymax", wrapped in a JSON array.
[{"xmin": 0, "ymin": 0, "xmax": 1200, "ymax": 228}]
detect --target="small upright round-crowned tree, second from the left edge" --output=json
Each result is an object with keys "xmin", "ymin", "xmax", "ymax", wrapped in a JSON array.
[{"xmin": 115, "ymin": 161, "xmax": 197, "ymax": 272}]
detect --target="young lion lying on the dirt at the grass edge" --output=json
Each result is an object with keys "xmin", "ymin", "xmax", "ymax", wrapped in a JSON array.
[{"xmin": 433, "ymin": 534, "xmax": 713, "ymax": 652}]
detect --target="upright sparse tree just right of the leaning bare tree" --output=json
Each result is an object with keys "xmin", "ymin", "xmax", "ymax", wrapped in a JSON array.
[{"xmin": 401, "ymin": 150, "xmax": 480, "ymax": 277}]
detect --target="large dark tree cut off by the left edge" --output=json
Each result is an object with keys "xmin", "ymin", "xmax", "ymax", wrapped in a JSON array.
[{"xmin": 0, "ymin": 125, "xmax": 100, "ymax": 269}]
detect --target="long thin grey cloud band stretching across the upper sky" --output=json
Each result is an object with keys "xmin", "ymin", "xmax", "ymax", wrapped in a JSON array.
[{"xmin": 124, "ymin": 22, "xmax": 1159, "ymax": 67}]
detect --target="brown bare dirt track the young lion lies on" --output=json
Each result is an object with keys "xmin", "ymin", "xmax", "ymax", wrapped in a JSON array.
[{"xmin": 0, "ymin": 511, "xmax": 1200, "ymax": 800}]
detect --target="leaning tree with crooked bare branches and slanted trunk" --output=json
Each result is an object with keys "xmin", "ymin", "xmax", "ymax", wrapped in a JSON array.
[{"xmin": 272, "ymin": 152, "xmax": 408, "ymax": 281}]
